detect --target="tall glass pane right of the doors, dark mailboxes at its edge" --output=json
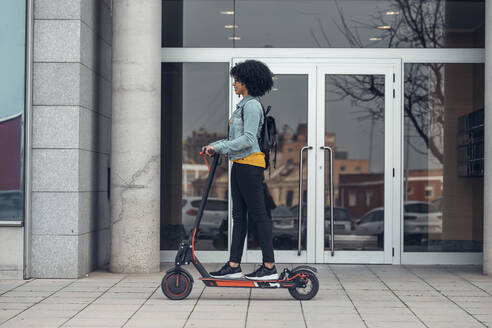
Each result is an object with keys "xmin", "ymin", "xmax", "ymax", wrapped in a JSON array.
[{"xmin": 404, "ymin": 64, "xmax": 484, "ymax": 252}]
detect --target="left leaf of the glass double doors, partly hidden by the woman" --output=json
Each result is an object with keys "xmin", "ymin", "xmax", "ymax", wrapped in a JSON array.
[{"xmin": 229, "ymin": 59, "xmax": 316, "ymax": 263}]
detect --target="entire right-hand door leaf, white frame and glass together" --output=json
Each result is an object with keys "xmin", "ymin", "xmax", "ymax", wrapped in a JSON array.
[{"xmin": 316, "ymin": 60, "xmax": 401, "ymax": 263}]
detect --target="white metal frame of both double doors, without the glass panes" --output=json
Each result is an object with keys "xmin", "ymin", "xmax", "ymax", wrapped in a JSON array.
[{"xmin": 235, "ymin": 57, "xmax": 403, "ymax": 264}]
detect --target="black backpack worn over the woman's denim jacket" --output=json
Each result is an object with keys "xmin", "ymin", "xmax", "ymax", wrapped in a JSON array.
[{"xmin": 241, "ymin": 102, "xmax": 278, "ymax": 169}]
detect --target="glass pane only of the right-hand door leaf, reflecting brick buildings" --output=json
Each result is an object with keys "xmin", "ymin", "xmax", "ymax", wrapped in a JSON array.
[{"xmin": 324, "ymin": 75, "xmax": 385, "ymax": 251}]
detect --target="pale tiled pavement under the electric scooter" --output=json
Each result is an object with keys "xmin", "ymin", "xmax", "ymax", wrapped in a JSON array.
[{"xmin": 0, "ymin": 264, "xmax": 492, "ymax": 328}]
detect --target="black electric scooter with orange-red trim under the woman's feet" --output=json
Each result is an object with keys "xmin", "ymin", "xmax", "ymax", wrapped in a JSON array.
[{"xmin": 161, "ymin": 153, "xmax": 319, "ymax": 300}]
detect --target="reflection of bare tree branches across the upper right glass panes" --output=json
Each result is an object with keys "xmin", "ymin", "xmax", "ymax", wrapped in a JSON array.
[{"xmin": 320, "ymin": 0, "xmax": 445, "ymax": 164}]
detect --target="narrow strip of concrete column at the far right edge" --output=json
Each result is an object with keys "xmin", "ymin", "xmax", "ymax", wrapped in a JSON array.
[{"xmin": 483, "ymin": 0, "xmax": 492, "ymax": 275}]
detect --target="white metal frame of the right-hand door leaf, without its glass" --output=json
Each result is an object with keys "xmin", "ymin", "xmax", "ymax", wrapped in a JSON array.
[{"xmin": 316, "ymin": 59, "xmax": 403, "ymax": 264}]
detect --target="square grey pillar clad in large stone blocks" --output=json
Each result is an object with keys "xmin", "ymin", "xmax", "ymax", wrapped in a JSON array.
[{"xmin": 31, "ymin": 0, "xmax": 112, "ymax": 278}]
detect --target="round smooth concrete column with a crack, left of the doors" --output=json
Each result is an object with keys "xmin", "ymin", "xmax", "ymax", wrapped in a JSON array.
[{"xmin": 110, "ymin": 0, "xmax": 162, "ymax": 273}]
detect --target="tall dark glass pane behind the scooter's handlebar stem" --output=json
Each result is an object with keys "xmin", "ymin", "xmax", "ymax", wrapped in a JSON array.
[{"xmin": 161, "ymin": 63, "xmax": 229, "ymax": 250}]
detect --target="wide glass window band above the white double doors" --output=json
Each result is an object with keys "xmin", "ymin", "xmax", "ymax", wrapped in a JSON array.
[{"xmin": 162, "ymin": 0, "xmax": 485, "ymax": 48}]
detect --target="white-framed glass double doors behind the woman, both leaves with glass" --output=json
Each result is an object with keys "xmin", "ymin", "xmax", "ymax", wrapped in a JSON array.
[{"xmin": 229, "ymin": 58, "xmax": 402, "ymax": 263}]
